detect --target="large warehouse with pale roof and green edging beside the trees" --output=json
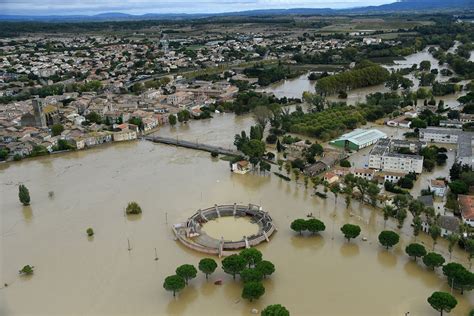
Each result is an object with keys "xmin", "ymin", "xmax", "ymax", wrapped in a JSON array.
[{"xmin": 330, "ymin": 128, "xmax": 387, "ymax": 150}]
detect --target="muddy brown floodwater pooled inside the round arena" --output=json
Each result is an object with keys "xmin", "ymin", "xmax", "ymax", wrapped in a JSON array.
[{"xmin": 202, "ymin": 216, "xmax": 258, "ymax": 241}]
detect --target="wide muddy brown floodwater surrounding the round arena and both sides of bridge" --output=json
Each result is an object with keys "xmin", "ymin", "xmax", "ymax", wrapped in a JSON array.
[{"xmin": 0, "ymin": 114, "xmax": 474, "ymax": 316}]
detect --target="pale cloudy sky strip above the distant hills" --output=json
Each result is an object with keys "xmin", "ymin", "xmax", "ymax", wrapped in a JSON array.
[{"xmin": 0, "ymin": 0, "xmax": 396, "ymax": 15}]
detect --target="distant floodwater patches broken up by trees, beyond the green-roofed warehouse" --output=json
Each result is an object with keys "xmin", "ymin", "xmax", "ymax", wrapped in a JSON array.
[{"xmin": 263, "ymin": 43, "xmax": 468, "ymax": 109}]
